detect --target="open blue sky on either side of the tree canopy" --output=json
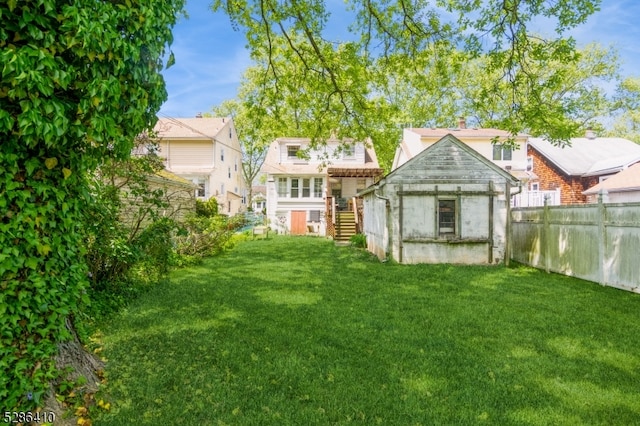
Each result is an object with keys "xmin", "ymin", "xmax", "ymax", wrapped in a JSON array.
[{"xmin": 159, "ymin": 0, "xmax": 640, "ymax": 117}]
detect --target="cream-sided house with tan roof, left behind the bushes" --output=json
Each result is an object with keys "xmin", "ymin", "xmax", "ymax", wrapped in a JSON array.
[{"xmin": 155, "ymin": 117, "xmax": 247, "ymax": 215}]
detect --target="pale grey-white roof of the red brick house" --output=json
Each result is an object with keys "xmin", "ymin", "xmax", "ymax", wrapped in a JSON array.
[{"xmin": 529, "ymin": 138, "xmax": 640, "ymax": 176}]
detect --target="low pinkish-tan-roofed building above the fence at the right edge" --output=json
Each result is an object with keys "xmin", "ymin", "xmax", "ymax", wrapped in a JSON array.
[{"xmin": 583, "ymin": 163, "xmax": 640, "ymax": 203}]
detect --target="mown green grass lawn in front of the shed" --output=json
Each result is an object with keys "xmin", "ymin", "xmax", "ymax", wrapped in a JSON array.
[{"xmin": 94, "ymin": 237, "xmax": 640, "ymax": 426}]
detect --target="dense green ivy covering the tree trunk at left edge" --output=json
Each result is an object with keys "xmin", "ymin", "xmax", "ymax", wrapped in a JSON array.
[{"xmin": 0, "ymin": 0, "xmax": 184, "ymax": 412}]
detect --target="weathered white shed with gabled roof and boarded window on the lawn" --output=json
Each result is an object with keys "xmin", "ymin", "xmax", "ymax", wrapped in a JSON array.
[{"xmin": 360, "ymin": 134, "xmax": 519, "ymax": 264}]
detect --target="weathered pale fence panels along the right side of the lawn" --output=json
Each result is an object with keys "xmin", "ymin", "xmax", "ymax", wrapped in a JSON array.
[{"xmin": 511, "ymin": 197, "xmax": 640, "ymax": 293}]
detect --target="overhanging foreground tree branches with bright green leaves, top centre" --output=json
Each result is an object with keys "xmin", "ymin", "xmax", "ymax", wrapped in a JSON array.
[{"xmin": 213, "ymin": 0, "xmax": 598, "ymax": 157}]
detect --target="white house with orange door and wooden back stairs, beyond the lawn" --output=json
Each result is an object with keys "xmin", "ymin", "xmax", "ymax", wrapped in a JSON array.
[{"xmin": 262, "ymin": 138, "xmax": 382, "ymax": 240}]
